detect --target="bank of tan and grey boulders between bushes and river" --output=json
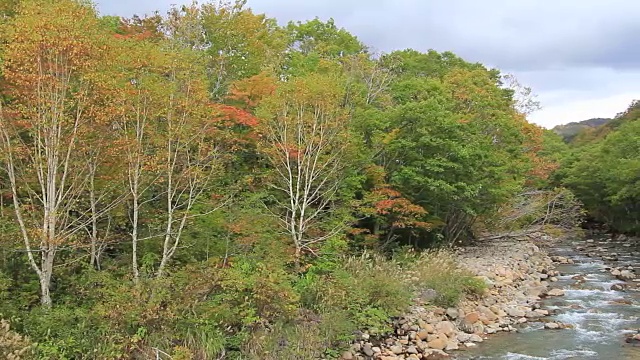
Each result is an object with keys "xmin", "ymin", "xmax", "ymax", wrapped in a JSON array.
[{"xmin": 342, "ymin": 235, "xmax": 571, "ymax": 360}]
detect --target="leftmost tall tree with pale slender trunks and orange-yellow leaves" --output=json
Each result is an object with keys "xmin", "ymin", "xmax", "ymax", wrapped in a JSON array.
[{"xmin": 0, "ymin": 0, "xmax": 112, "ymax": 307}]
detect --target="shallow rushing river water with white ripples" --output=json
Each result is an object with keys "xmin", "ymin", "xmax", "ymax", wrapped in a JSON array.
[{"xmin": 456, "ymin": 241, "xmax": 640, "ymax": 360}]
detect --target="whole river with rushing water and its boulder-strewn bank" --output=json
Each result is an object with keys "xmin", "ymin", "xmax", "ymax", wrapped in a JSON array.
[{"xmin": 343, "ymin": 234, "xmax": 640, "ymax": 360}]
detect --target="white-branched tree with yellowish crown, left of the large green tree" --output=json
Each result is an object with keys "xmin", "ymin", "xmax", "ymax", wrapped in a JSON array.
[{"xmin": 258, "ymin": 75, "xmax": 349, "ymax": 260}]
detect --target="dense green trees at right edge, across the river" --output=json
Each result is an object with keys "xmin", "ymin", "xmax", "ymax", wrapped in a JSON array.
[{"xmin": 553, "ymin": 101, "xmax": 640, "ymax": 234}]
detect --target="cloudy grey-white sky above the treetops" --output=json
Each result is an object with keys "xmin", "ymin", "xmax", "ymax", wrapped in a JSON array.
[{"xmin": 97, "ymin": 0, "xmax": 640, "ymax": 127}]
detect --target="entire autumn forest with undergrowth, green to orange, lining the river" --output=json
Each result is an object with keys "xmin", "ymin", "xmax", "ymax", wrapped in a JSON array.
[{"xmin": 0, "ymin": 0, "xmax": 640, "ymax": 360}]
